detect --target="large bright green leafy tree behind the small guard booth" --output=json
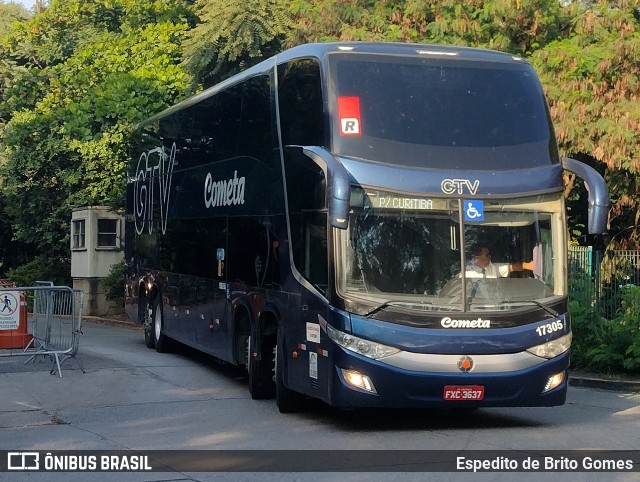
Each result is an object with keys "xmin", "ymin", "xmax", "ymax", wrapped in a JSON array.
[{"xmin": 0, "ymin": 0, "xmax": 195, "ymax": 276}]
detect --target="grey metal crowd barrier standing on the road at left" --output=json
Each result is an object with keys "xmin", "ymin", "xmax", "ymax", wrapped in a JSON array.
[{"xmin": 0, "ymin": 281, "xmax": 85, "ymax": 378}]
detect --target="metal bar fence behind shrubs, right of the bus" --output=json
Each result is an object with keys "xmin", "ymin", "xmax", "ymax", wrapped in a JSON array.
[{"xmin": 569, "ymin": 246, "xmax": 640, "ymax": 319}]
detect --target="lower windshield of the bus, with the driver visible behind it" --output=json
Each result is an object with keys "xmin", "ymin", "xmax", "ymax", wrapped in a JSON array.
[{"xmin": 334, "ymin": 190, "xmax": 566, "ymax": 314}]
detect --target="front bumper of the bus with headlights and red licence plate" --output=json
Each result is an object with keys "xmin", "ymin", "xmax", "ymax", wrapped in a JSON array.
[{"xmin": 328, "ymin": 348, "xmax": 569, "ymax": 408}]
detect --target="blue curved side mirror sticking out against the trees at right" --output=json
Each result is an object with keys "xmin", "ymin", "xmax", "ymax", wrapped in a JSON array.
[{"xmin": 562, "ymin": 157, "xmax": 609, "ymax": 234}]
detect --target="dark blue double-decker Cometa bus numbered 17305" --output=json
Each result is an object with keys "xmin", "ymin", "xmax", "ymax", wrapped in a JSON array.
[{"xmin": 125, "ymin": 42, "xmax": 609, "ymax": 413}]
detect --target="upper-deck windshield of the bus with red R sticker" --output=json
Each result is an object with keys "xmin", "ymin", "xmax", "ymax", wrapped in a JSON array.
[{"xmin": 329, "ymin": 53, "xmax": 559, "ymax": 169}]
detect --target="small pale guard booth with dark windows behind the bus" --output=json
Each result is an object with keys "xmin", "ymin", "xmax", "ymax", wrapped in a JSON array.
[{"xmin": 71, "ymin": 206, "xmax": 124, "ymax": 316}]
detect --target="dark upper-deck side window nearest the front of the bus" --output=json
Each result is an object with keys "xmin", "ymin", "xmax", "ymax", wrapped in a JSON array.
[{"xmin": 278, "ymin": 59, "xmax": 326, "ymax": 146}]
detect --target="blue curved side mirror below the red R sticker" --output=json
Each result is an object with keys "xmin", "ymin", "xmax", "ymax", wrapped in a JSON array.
[{"xmin": 302, "ymin": 146, "xmax": 351, "ymax": 229}]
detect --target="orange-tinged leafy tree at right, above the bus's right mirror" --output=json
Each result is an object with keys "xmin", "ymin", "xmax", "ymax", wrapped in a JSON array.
[{"xmin": 532, "ymin": 0, "xmax": 640, "ymax": 249}]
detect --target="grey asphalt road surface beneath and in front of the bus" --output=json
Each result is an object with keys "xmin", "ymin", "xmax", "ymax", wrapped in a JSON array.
[{"xmin": 0, "ymin": 323, "xmax": 640, "ymax": 481}]
